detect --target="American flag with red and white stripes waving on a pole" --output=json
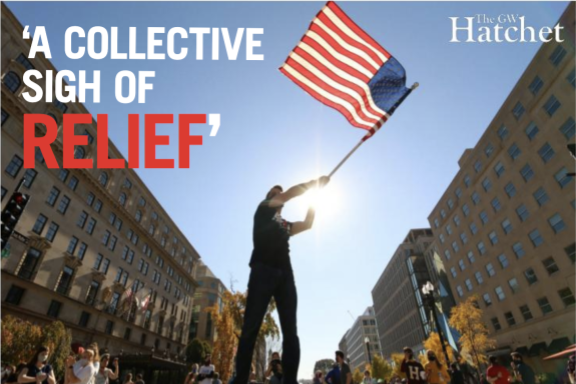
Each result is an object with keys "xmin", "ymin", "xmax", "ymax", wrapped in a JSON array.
[{"xmin": 280, "ymin": 1, "xmax": 411, "ymax": 138}]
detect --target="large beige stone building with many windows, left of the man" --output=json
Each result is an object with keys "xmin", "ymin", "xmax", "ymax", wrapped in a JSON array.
[{"xmin": 1, "ymin": 3, "xmax": 200, "ymax": 376}]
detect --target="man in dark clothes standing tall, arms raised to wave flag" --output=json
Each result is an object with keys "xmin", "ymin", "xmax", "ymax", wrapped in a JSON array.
[{"xmin": 234, "ymin": 176, "xmax": 330, "ymax": 384}]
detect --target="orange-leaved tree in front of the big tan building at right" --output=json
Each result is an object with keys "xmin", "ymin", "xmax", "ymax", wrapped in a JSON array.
[{"xmin": 449, "ymin": 295, "xmax": 496, "ymax": 376}]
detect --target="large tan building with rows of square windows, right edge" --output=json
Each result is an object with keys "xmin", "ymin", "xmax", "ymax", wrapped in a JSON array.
[{"xmin": 429, "ymin": 3, "xmax": 575, "ymax": 369}]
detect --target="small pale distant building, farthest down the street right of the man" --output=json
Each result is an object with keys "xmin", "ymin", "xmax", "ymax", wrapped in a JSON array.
[{"xmin": 340, "ymin": 307, "xmax": 382, "ymax": 372}]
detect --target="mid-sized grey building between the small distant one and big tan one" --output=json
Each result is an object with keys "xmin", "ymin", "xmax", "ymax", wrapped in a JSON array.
[{"xmin": 372, "ymin": 229, "xmax": 433, "ymax": 357}]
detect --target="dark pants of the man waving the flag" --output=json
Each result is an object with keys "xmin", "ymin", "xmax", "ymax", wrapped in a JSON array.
[{"xmin": 234, "ymin": 264, "xmax": 300, "ymax": 384}]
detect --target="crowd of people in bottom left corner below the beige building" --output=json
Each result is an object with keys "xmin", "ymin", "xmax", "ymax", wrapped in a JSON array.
[{"xmin": 1, "ymin": 343, "xmax": 145, "ymax": 384}]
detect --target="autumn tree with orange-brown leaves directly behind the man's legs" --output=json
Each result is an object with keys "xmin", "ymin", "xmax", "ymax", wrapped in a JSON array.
[{"xmin": 206, "ymin": 291, "xmax": 280, "ymax": 382}]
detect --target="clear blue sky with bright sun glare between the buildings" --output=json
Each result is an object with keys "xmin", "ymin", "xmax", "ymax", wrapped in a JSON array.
[{"xmin": 8, "ymin": 2, "xmax": 567, "ymax": 378}]
